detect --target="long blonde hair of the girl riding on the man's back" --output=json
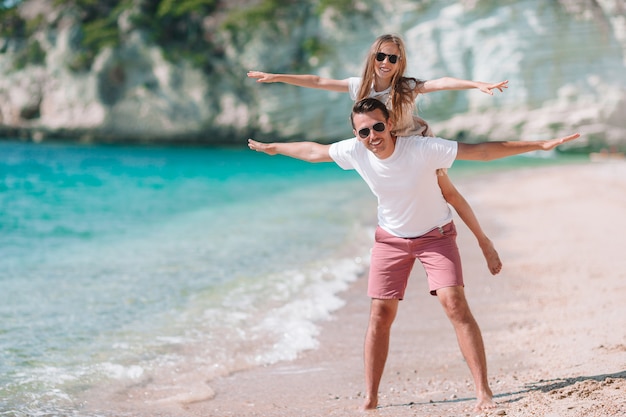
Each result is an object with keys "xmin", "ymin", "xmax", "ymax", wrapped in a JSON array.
[{"xmin": 356, "ymin": 34, "xmax": 424, "ymax": 132}]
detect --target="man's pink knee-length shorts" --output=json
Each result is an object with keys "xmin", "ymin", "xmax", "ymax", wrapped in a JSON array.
[{"xmin": 367, "ymin": 222, "xmax": 463, "ymax": 300}]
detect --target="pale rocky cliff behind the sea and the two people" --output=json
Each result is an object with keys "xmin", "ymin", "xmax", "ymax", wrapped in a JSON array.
[{"xmin": 0, "ymin": 0, "xmax": 626, "ymax": 148}]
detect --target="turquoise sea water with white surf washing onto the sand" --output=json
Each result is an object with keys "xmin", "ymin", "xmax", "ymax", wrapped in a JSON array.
[{"xmin": 0, "ymin": 141, "xmax": 576, "ymax": 416}]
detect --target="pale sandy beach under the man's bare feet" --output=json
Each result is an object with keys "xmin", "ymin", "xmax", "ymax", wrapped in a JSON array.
[{"xmin": 91, "ymin": 161, "xmax": 626, "ymax": 417}]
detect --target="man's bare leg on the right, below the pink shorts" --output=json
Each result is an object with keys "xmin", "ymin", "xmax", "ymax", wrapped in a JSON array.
[{"xmin": 437, "ymin": 286, "xmax": 496, "ymax": 411}]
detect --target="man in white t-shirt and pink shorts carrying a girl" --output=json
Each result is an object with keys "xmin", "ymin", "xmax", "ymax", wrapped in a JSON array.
[{"xmin": 248, "ymin": 98, "xmax": 580, "ymax": 411}]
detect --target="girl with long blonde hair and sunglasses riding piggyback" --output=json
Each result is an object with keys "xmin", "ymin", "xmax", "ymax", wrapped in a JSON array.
[{"xmin": 248, "ymin": 34, "xmax": 508, "ymax": 275}]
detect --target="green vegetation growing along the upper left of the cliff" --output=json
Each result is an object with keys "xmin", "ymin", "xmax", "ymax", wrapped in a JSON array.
[{"xmin": 0, "ymin": 0, "xmax": 363, "ymax": 73}]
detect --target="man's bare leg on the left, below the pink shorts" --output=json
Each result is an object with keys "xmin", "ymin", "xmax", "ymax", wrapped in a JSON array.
[{"xmin": 362, "ymin": 299, "xmax": 398, "ymax": 410}]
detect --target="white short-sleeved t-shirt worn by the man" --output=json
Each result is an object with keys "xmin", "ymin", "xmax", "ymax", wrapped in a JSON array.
[{"xmin": 329, "ymin": 136, "xmax": 458, "ymax": 237}]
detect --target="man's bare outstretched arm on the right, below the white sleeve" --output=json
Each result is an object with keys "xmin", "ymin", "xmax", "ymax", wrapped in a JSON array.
[{"xmin": 456, "ymin": 133, "xmax": 580, "ymax": 161}]
